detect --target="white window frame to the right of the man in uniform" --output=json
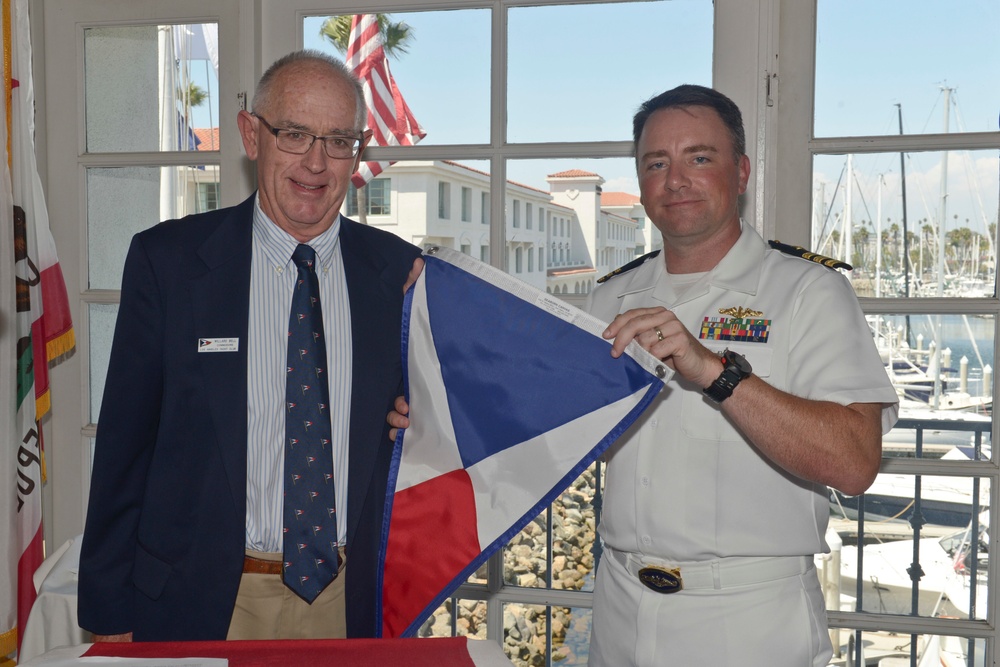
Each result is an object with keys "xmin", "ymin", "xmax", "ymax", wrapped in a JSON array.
[{"xmin": 772, "ymin": 1, "xmax": 1000, "ymax": 664}]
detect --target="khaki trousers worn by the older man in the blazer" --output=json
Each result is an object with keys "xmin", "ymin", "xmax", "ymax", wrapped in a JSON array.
[{"xmin": 226, "ymin": 548, "xmax": 347, "ymax": 639}]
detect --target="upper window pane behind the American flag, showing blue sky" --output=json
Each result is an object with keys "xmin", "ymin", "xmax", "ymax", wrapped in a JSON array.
[{"xmin": 302, "ymin": 9, "xmax": 490, "ymax": 145}]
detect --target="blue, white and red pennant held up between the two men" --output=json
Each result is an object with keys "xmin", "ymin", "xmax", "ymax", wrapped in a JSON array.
[{"xmin": 378, "ymin": 248, "xmax": 672, "ymax": 637}]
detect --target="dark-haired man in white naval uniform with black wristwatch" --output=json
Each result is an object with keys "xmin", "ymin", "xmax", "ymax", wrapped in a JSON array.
[{"xmin": 589, "ymin": 86, "xmax": 898, "ymax": 667}]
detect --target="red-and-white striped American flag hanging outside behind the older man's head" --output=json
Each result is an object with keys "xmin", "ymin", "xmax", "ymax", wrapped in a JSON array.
[{"xmin": 347, "ymin": 14, "xmax": 427, "ymax": 188}]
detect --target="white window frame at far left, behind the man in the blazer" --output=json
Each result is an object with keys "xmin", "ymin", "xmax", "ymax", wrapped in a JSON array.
[{"xmin": 40, "ymin": 0, "xmax": 249, "ymax": 560}]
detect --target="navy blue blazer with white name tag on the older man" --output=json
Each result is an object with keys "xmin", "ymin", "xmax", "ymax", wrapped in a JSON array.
[{"xmin": 78, "ymin": 197, "xmax": 420, "ymax": 641}]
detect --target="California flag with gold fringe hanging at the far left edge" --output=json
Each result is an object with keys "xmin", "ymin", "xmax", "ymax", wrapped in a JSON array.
[{"xmin": 0, "ymin": 0, "xmax": 75, "ymax": 656}]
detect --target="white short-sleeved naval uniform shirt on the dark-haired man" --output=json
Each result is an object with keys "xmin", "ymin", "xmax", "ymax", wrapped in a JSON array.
[{"xmin": 589, "ymin": 223, "xmax": 898, "ymax": 561}]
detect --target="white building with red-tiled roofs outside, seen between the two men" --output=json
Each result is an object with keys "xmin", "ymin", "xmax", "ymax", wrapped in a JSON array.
[{"xmin": 332, "ymin": 160, "xmax": 651, "ymax": 294}]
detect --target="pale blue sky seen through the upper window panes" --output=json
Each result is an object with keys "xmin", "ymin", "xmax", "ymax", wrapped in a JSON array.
[{"xmin": 184, "ymin": 0, "xmax": 1000, "ymax": 240}]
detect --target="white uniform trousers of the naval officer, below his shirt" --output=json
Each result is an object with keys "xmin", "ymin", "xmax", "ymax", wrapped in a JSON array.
[{"xmin": 588, "ymin": 547, "xmax": 833, "ymax": 667}]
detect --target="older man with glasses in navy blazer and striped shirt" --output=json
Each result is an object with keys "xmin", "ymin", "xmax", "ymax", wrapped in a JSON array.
[{"xmin": 79, "ymin": 51, "xmax": 419, "ymax": 641}]
